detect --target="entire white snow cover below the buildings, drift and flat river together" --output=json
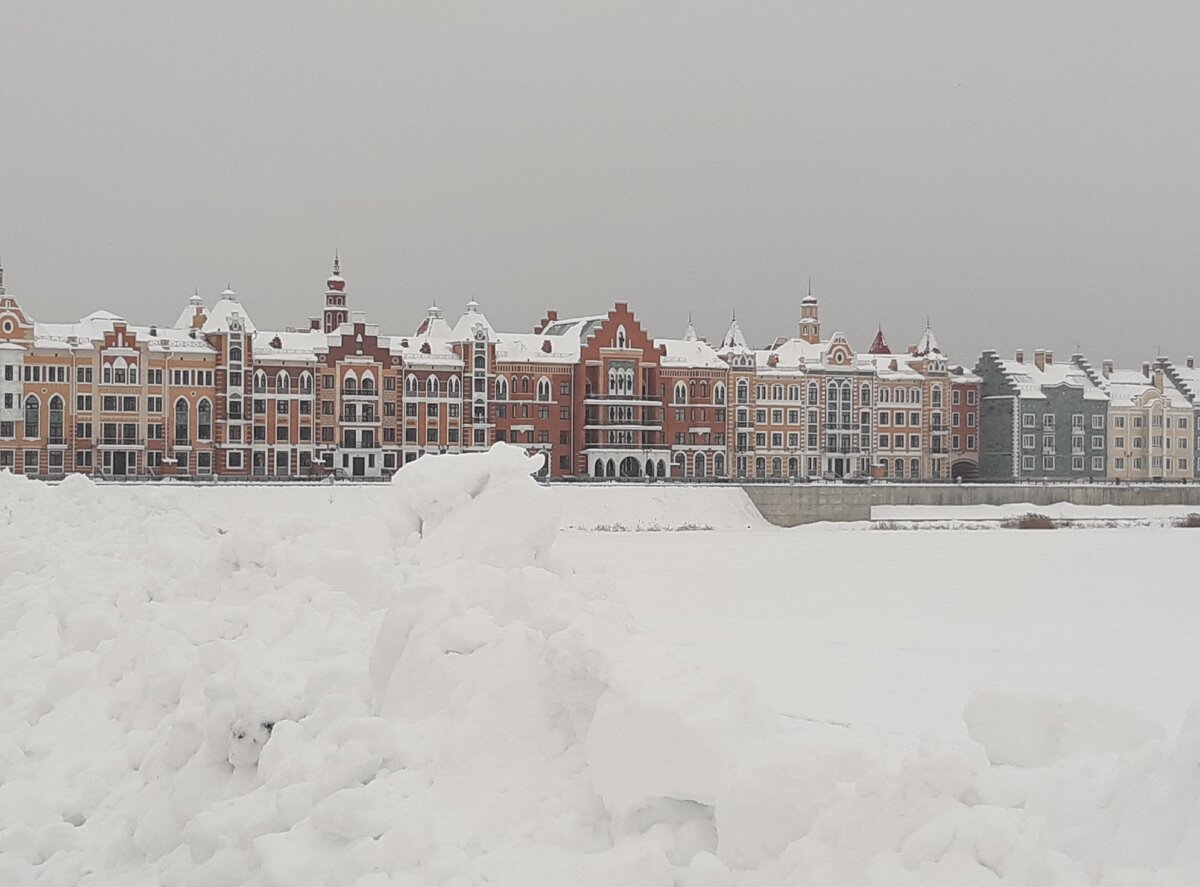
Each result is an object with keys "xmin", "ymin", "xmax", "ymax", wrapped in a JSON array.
[{"xmin": 0, "ymin": 447, "xmax": 1200, "ymax": 887}]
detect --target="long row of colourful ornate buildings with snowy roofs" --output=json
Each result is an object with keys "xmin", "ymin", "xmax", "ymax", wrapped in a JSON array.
[{"xmin": 0, "ymin": 259, "xmax": 1200, "ymax": 480}]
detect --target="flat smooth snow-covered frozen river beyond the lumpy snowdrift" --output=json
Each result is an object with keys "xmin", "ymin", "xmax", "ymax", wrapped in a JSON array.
[{"xmin": 556, "ymin": 527, "xmax": 1200, "ymax": 738}]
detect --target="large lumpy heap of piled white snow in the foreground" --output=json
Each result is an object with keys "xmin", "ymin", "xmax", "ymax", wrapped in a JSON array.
[{"xmin": 0, "ymin": 445, "xmax": 1200, "ymax": 887}]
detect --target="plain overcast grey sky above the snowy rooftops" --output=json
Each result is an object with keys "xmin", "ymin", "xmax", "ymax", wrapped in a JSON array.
[{"xmin": 0, "ymin": 0, "xmax": 1200, "ymax": 364}]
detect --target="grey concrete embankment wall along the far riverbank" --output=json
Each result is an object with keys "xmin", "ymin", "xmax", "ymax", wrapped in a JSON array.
[{"xmin": 743, "ymin": 484, "xmax": 1200, "ymax": 527}]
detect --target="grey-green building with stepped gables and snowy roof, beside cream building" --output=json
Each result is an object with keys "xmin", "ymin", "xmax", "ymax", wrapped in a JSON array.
[{"xmin": 974, "ymin": 350, "xmax": 1109, "ymax": 480}]
